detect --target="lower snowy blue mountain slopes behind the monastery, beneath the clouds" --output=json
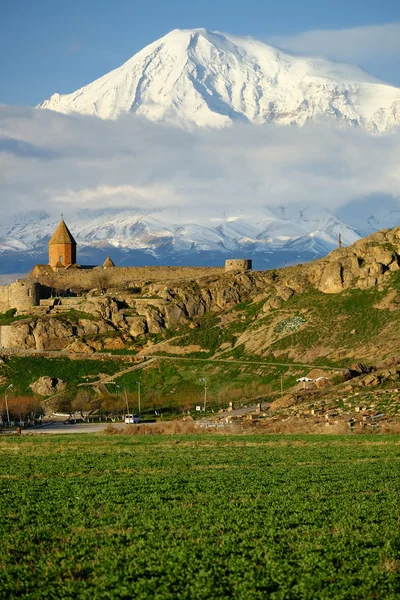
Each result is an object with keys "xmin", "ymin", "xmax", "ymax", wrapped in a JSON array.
[{"xmin": 0, "ymin": 207, "xmax": 359, "ymax": 271}]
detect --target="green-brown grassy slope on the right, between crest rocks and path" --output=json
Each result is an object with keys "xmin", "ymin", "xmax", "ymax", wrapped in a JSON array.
[{"xmin": 154, "ymin": 273, "xmax": 400, "ymax": 367}]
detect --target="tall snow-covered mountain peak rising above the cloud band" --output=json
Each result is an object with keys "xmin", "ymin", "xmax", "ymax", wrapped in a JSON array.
[{"xmin": 38, "ymin": 29, "xmax": 400, "ymax": 133}]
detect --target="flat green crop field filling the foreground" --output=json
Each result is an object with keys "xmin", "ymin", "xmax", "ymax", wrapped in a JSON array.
[{"xmin": 0, "ymin": 434, "xmax": 400, "ymax": 600}]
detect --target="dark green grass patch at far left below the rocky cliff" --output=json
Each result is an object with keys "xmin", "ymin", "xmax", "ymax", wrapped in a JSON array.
[{"xmin": 0, "ymin": 356, "xmax": 124, "ymax": 395}]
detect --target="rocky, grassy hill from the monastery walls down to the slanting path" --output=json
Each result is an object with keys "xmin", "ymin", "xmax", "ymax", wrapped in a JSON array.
[{"xmin": 1, "ymin": 228, "xmax": 400, "ymax": 365}]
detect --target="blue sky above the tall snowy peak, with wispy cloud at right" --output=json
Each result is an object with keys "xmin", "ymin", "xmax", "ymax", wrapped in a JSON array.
[{"xmin": 0, "ymin": 0, "xmax": 400, "ymax": 105}]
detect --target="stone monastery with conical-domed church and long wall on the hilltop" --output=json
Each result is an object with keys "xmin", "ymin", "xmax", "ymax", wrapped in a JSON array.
[{"xmin": 0, "ymin": 219, "xmax": 252, "ymax": 314}]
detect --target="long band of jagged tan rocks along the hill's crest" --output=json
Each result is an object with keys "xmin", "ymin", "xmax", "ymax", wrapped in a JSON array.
[{"xmin": 1, "ymin": 228, "xmax": 400, "ymax": 353}]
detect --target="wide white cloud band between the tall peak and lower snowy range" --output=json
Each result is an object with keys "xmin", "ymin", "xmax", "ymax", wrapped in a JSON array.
[{"xmin": 0, "ymin": 106, "xmax": 400, "ymax": 222}]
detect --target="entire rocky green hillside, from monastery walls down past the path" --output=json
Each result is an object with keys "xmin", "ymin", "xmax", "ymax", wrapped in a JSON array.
[{"xmin": 0, "ymin": 228, "xmax": 400, "ymax": 418}]
